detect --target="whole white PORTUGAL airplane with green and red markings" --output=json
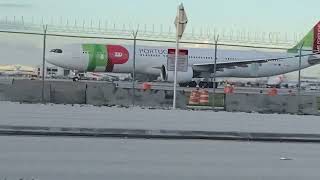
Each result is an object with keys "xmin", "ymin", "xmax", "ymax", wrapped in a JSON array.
[{"xmin": 47, "ymin": 22, "xmax": 320, "ymax": 86}]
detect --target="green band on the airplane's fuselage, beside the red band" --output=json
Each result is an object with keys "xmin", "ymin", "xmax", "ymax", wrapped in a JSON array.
[{"xmin": 82, "ymin": 44, "xmax": 108, "ymax": 71}]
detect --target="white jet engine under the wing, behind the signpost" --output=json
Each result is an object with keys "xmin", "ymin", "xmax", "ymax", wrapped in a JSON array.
[{"xmin": 160, "ymin": 66, "xmax": 193, "ymax": 83}]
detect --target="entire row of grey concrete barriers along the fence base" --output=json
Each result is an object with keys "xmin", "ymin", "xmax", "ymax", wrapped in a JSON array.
[{"xmin": 0, "ymin": 80, "xmax": 320, "ymax": 115}]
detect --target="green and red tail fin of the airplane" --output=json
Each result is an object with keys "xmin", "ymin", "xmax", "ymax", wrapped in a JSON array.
[{"xmin": 288, "ymin": 21, "xmax": 320, "ymax": 53}]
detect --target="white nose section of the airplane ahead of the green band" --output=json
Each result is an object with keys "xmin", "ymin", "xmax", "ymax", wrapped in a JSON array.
[{"xmin": 46, "ymin": 52, "xmax": 89, "ymax": 71}]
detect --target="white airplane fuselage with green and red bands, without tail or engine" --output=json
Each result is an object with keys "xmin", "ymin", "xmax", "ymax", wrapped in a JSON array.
[{"xmin": 47, "ymin": 44, "xmax": 319, "ymax": 78}]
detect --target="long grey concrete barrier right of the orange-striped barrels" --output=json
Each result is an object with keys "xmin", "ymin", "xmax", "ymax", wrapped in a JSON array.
[{"xmin": 226, "ymin": 94, "xmax": 319, "ymax": 115}]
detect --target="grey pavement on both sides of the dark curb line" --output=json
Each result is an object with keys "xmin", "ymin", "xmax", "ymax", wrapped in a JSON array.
[{"xmin": 0, "ymin": 95, "xmax": 320, "ymax": 180}]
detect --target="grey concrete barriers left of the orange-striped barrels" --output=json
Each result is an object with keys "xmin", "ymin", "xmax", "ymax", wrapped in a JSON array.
[{"xmin": 0, "ymin": 80, "xmax": 188, "ymax": 109}]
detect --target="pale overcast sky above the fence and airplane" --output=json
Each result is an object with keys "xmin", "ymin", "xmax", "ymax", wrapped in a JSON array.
[{"xmin": 0, "ymin": 0, "xmax": 320, "ymax": 73}]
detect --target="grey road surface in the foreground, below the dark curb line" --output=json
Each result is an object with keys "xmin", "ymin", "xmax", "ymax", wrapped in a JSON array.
[{"xmin": 0, "ymin": 136, "xmax": 320, "ymax": 180}]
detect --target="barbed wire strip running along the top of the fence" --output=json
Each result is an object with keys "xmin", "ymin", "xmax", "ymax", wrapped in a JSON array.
[{"xmin": 0, "ymin": 16, "xmax": 302, "ymax": 49}]
